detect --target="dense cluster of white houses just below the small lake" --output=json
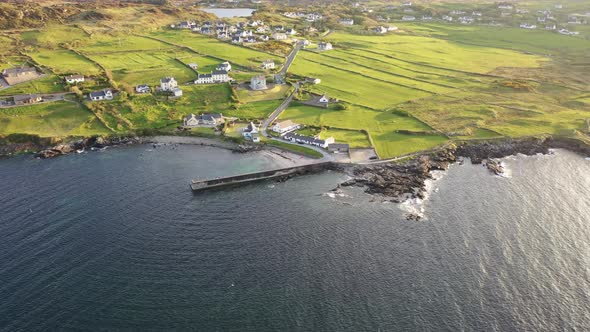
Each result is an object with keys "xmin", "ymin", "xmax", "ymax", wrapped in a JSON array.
[{"xmin": 170, "ymin": 20, "xmax": 297, "ymax": 44}]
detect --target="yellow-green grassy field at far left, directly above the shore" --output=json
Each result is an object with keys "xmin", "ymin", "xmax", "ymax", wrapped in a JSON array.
[{"xmin": 0, "ymin": 102, "xmax": 108, "ymax": 137}]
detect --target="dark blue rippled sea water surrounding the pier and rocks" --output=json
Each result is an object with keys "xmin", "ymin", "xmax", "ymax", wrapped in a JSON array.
[{"xmin": 0, "ymin": 146, "xmax": 590, "ymax": 331}]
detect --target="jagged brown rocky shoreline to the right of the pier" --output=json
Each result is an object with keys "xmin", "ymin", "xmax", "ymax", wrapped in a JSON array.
[{"xmin": 334, "ymin": 138, "xmax": 590, "ymax": 206}]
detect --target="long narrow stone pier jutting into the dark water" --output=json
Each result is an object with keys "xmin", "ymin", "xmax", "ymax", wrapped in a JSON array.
[{"xmin": 190, "ymin": 161, "xmax": 333, "ymax": 192}]
